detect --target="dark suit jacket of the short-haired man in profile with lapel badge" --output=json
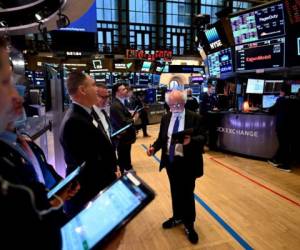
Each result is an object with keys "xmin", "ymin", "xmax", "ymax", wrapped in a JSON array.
[{"xmin": 60, "ymin": 104, "xmax": 117, "ymax": 212}]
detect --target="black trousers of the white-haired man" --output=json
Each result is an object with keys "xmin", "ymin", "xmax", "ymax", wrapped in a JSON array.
[{"xmin": 166, "ymin": 156, "xmax": 196, "ymax": 226}]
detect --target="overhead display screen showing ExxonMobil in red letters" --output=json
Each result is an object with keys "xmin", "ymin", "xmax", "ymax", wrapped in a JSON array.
[{"xmin": 235, "ymin": 37, "xmax": 285, "ymax": 71}]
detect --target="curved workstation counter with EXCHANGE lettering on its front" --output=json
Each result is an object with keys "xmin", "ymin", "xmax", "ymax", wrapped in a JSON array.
[{"xmin": 207, "ymin": 111, "xmax": 278, "ymax": 159}]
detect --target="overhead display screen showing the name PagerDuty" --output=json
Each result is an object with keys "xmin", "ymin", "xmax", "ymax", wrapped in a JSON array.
[{"xmin": 230, "ymin": 3, "xmax": 285, "ymax": 45}]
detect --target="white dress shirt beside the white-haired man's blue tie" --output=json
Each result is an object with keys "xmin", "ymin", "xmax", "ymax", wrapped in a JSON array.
[{"xmin": 167, "ymin": 110, "xmax": 185, "ymax": 157}]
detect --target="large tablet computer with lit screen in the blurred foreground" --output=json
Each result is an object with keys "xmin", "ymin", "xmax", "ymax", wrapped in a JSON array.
[{"xmin": 61, "ymin": 173, "xmax": 155, "ymax": 250}]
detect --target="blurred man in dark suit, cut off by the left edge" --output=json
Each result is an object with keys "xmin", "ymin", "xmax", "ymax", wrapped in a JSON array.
[{"xmin": 0, "ymin": 36, "xmax": 62, "ymax": 249}]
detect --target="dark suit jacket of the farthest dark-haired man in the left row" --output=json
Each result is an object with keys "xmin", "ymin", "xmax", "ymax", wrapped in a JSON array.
[{"xmin": 110, "ymin": 98, "xmax": 136, "ymax": 144}]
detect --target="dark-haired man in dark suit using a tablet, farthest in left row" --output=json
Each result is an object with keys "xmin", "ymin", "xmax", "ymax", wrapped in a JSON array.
[{"xmin": 110, "ymin": 83, "xmax": 138, "ymax": 173}]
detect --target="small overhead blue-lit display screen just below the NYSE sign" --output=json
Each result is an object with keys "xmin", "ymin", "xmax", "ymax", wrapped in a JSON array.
[{"xmin": 208, "ymin": 48, "xmax": 233, "ymax": 78}]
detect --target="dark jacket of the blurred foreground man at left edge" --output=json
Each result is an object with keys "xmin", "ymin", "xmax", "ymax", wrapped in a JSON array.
[{"xmin": 0, "ymin": 141, "xmax": 67, "ymax": 249}]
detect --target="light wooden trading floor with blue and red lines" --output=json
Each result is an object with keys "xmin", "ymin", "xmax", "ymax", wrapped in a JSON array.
[{"xmin": 101, "ymin": 125, "xmax": 300, "ymax": 250}]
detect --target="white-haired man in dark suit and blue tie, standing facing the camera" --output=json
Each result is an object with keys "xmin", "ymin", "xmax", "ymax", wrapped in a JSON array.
[{"xmin": 147, "ymin": 90, "xmax": 205, "ymax": 244}]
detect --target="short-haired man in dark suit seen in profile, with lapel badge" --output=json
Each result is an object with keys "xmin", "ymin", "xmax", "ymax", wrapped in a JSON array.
[{"xmin": 60, "ymin": 71, "xmax": 117, "ymax": 215}]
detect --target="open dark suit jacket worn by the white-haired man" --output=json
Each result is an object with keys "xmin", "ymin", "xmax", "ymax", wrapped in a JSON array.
[{"xmin": 153, "ymin": 110, "xmax": 205, "ymax": 178}]
